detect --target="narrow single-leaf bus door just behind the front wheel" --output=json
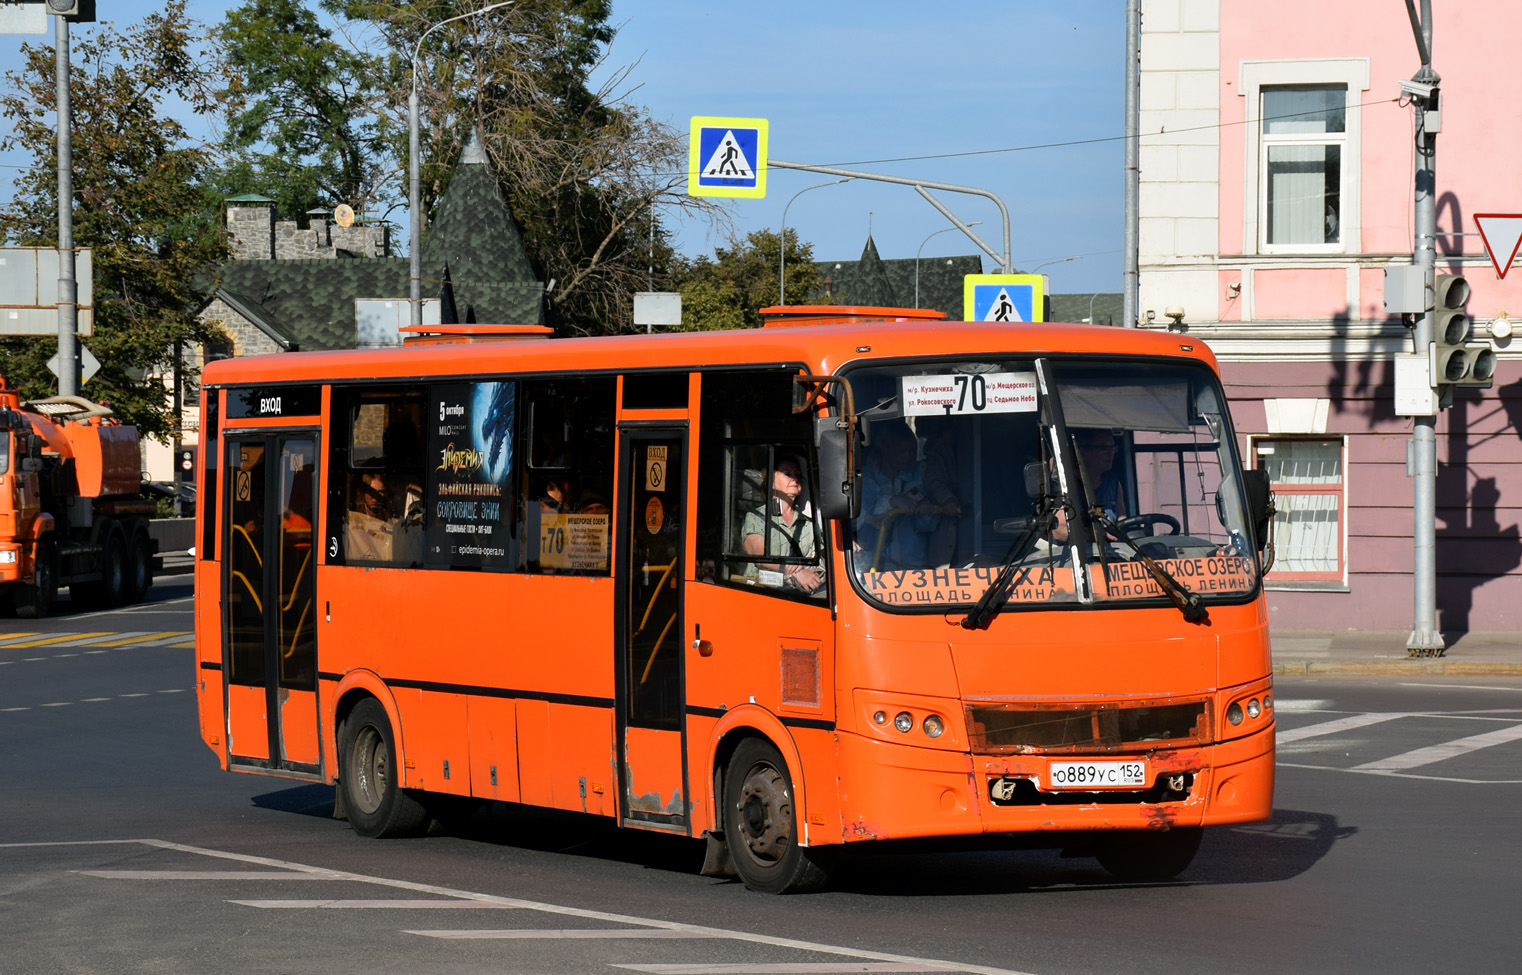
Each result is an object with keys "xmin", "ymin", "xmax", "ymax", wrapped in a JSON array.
[{"xmin": 616, "ymin": 427, "xmax": 691, "ymax": 834}]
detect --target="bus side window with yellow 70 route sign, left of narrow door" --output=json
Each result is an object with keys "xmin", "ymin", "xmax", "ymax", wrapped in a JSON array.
[{"xmin": 517, "ymin": 379, "xmax": 616, "ymax": 575}]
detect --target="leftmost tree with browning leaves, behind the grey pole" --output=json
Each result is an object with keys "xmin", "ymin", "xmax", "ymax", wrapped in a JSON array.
[{"xmin": 0, "ymin": 0, "xmax": 227, "ymax": 440}]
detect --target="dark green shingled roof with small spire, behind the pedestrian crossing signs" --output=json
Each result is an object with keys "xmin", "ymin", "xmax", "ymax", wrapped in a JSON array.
[{"xmin": 810, "ymin": 236, "xmax": 983, "ymax": 319}]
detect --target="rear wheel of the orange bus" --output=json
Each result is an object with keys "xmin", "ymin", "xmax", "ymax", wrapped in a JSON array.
[{"xmin": 338, "ymin": 698, "xmax": 428, "ymax": 838}]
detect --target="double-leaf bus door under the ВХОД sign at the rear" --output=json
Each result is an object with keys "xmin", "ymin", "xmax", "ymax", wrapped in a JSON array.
[{"xmin": 222, "ymin": 434, "xmax": 321, "ymax": 776}]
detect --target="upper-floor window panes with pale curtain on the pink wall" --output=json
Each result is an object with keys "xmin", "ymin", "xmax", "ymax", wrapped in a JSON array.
[{"xmin": 1260, "ymin": 85, "xmax": 1347, "ymax": 248}]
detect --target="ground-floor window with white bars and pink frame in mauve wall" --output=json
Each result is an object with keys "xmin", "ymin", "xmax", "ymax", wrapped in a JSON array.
[{"xmin": 1254, "ymin": 437, "xmax": 1347, "ymax": 583}]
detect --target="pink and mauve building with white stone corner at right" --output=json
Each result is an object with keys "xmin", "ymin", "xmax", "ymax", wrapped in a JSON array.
[{"xmin": 1138, "ymin": 0, "xmax": 1522, "ymax": 633}]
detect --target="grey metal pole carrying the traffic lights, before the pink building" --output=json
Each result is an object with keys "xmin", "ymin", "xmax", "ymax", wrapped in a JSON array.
[{"xmin": 1402, "ymin": 0, "xmax": 1443, "ymax": 657}]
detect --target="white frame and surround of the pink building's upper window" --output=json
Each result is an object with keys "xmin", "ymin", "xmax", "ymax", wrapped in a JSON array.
[{"xmin": 1237, "ymin": 58, "xmax": 1368, "ymax": 256}]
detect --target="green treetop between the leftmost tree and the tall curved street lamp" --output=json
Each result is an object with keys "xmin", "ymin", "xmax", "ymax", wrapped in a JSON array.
[{"xmin": 218, "ymin": 0, "xmax": 395, "ymax": 218}]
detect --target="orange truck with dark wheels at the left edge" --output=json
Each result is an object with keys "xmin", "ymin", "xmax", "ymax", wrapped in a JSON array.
[{"xmin": 0, "ymin": 379, "xmax": 157, "ymax": 619}]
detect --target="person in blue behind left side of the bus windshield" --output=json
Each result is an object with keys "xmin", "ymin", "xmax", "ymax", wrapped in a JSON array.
[{"xmin": 857, "ymin": 420, "xmax": 941, "ymax": 570}]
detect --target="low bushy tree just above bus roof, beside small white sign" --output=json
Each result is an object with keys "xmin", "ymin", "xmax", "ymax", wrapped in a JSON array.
[{"xmin": 676, "ymin": 230, "xmax": 826, "ymax": 332}]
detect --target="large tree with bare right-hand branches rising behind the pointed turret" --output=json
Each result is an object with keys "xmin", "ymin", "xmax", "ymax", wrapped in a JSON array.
[{"xmin": 318, "ymin": 0, "xmax": 728, "ymax": 335}]
